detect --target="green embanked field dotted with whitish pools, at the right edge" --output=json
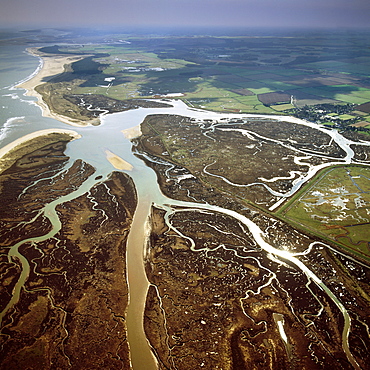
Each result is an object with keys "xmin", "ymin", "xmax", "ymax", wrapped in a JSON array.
[{"xmin": 278, "ymin": 166, "xmax": 370, "ymax": 259}]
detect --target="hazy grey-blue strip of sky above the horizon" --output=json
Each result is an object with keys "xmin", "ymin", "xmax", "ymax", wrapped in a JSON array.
[{"xmin": 0, "ymin": 0, "xmax": 370, "ymax": 28}]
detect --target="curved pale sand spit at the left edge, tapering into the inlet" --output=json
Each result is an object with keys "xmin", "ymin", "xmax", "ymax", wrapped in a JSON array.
[{"xmin": 0, "ymin": 129, "xmax": 81, "ymax": 173}]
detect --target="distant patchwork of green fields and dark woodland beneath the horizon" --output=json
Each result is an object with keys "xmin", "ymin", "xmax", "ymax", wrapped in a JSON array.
[{"xmin": 40, "ymin": 35, "xmax": 370, "ymax": 117}]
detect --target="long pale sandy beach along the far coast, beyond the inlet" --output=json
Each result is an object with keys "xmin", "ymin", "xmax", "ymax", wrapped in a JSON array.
[{"xmin": 16, "ymin": 48, "xmax": 91, "ymax": 127}]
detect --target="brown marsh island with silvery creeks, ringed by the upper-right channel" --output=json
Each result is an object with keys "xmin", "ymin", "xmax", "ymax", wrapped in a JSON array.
[{"xmin": 136, "ymin": 115, "xmax": 344, "ymax": 210}]
